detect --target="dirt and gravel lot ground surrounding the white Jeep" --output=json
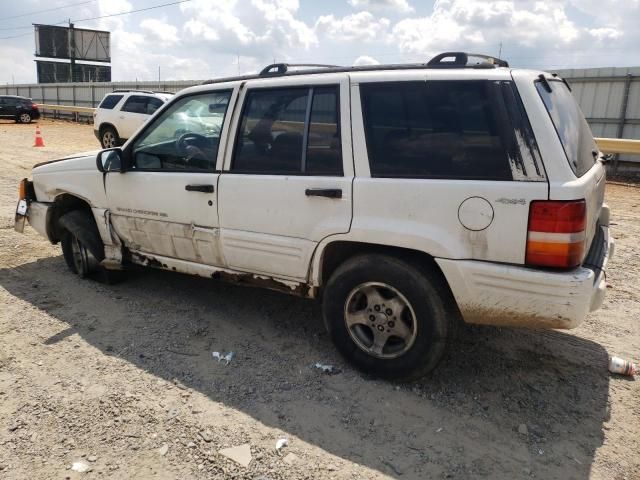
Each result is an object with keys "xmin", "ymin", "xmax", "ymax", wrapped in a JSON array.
[{"xmin": 0, "ymin": 117, "xmax": 640, "ymax": 480}]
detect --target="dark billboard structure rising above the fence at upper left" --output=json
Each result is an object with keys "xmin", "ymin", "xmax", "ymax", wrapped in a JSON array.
[{"xmin": 34, "ymin": 23, "xmax": 111, "ymax": 83}]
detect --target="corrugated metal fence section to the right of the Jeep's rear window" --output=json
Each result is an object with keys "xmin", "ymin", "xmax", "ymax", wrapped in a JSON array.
[{"xmin": 556, "ymin": 67, "xmax": 640, "ymax": 166}]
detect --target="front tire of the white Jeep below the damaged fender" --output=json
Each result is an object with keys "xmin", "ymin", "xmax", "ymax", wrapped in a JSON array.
[{"xmin": 60, "ymin": 210, "xmax": 125, "ymax": 284}]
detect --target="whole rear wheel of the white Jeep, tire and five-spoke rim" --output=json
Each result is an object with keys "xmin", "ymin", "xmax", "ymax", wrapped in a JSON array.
[{"xmin": 322, "ymin": 254, "xmax": 456, "ymax": 380}]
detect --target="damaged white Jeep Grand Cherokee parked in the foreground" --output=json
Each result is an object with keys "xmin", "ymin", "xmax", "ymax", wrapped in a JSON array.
[{"xmin": 16, "ymin": 52, "xmax": 613, "ymax": 379}]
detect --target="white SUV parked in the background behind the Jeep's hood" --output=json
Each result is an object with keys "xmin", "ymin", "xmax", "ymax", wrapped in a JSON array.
[{"xmin": 93, "ymin": 90, "xmax": 173, "ymax": 148}]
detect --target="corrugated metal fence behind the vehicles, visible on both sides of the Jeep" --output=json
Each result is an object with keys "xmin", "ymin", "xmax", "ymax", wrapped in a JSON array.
[{"xmin": 0, "ymin": 67, "xmax": 640, "ymax": 166}]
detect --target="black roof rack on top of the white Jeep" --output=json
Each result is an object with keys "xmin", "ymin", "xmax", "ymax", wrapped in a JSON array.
[{"xmin": 202, "ymin": 52, "xmax": 509, "ymax": 85}]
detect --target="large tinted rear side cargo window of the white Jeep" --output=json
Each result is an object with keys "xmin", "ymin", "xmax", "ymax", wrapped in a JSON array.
[{"xmin": 360, "ymin": 81, "xmax": 513, "ymax": 180}]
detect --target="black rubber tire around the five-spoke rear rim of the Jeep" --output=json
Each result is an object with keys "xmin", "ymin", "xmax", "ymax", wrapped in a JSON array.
[{"xmin": 322, "ymin": 254, "xmax": 457, "ymax": 380}]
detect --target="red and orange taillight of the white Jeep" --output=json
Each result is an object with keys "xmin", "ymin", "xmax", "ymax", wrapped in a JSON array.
[{"xmin": 525, "ymin": 200, "xmax": 587, "ymax": 267}]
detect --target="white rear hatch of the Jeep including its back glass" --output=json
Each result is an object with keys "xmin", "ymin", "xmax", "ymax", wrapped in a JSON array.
[{"xmin": 536, "ymin": 75, "xmax": 606, "ymax": 259}]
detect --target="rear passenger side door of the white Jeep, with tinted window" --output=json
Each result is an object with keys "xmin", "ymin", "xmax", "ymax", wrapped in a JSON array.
[{"xmin": 218, "ymin": 75, "xmax": 353, "ymax": 280}]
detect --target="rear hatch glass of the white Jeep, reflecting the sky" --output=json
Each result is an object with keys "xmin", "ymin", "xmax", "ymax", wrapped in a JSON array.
[{"xmin": 536, "ymin": 80, "xmax": 598, "ymax": 177}]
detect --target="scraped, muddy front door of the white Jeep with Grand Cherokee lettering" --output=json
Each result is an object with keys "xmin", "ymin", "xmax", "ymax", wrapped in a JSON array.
[{"xmin": 105, "ymin": 90, "xmax": 232, "ymax": 266}]
